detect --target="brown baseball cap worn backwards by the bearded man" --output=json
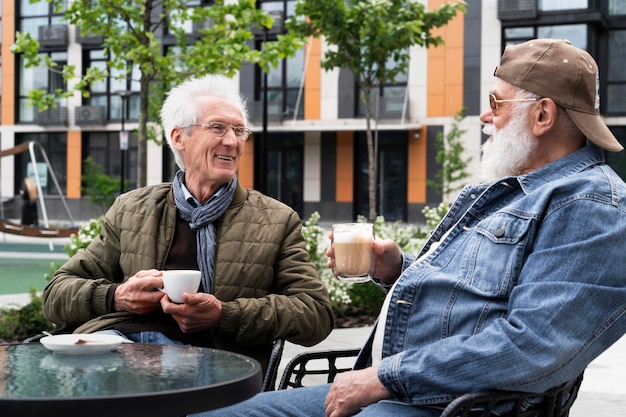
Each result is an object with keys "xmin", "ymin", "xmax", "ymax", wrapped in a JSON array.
[{"xmin": 494, "ymin": 39, "xmax": 624, "ymax": 152}]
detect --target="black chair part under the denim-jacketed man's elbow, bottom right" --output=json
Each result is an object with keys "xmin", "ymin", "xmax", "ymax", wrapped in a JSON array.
[{"xmin": 440, "ymin": 374, "xmax": 583, "ymax": 417}]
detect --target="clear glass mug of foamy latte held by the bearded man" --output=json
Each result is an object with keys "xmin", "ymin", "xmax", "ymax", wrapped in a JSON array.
[{"xmin": 332, "ymin": 223, "xmax": 374, "ymax": 282}]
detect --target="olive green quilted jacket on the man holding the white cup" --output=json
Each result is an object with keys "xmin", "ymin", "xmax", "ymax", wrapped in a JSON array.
[{"xmin": 43, "ymin": 183, "xmax": 333, "ymax": 365}]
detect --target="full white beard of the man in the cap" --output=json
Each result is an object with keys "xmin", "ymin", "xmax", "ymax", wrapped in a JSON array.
[{"xmin": 479, "ymin": 109, "xmax": 537, "ymax": 182}]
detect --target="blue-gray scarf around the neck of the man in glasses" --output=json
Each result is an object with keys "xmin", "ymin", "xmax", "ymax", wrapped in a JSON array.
[{"xmin": 173, "ymin": 171, "xmax": 237, "ymax": 293}]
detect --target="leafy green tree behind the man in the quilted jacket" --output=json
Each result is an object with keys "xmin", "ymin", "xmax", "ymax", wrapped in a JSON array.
[{"xmin": 12, "ymin": 0, "xmax": 304, "ymax": 187}]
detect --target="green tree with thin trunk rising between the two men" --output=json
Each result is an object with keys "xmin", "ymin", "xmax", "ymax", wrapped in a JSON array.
[{"xmin": 287, "ymin": 0, "xmax": 465, "ymax": 222}]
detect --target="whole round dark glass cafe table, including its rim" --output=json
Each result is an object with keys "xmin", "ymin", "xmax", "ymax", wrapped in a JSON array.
[{"xmin": 0, "ymin": 343, "xmax": 261, "ymax": 417}]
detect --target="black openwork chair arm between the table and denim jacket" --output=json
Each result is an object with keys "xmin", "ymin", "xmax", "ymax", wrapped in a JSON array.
[{"xmin": 278, "ymin": 349, "xmax": 359, "ymax": 389}]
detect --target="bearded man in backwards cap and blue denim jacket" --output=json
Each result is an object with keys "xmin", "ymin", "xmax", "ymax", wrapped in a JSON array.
[{"xmin": 195, "ymin": 39, "xmax": 626, "ymax": 417}]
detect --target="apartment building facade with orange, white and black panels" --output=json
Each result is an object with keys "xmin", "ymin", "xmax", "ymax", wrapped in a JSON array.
[{"xmin": 0, "ymin": 0, "xmax": 626, "ymax": 222}]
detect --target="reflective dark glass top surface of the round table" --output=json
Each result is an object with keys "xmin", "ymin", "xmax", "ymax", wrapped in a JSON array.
[{"xmin": 0, "ymin": 343, "xmax": 260, "ymax": 399}]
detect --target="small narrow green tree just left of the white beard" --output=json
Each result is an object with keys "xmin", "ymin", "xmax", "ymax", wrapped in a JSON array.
[{"xmin": 427, "ymin": 108, "xmax": 472, "ymax": 198}]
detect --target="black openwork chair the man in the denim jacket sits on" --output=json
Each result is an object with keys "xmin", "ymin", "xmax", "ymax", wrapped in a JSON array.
[{"xmin": 278, "ymin": 349, "xmax": 583, "ymax": 417}]
